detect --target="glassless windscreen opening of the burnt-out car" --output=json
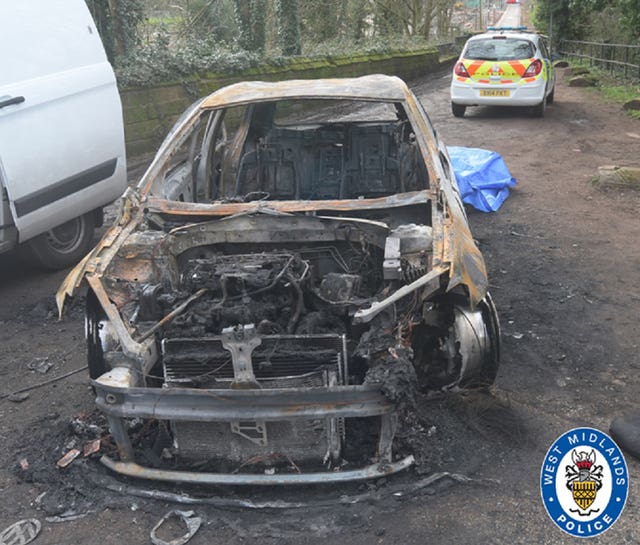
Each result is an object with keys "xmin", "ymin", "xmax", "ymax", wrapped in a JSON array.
[{"xmin": 158, "ymin": 99, "xmax": 429, "ymax": 202}]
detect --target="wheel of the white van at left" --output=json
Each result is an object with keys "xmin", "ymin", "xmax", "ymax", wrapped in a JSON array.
[{"xmin": 28, "ymin": 210, "xmax": 96, "ymax": 271}]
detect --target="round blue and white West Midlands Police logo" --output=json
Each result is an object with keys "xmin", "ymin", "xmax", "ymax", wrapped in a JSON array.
[{"xmin": 540, "ymin": 428, "xmax": 629, "ymax": 537}]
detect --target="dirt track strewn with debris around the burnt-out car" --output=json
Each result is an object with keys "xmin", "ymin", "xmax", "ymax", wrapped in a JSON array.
[{"xmin": 0, "ymin": 62, "xmax": 640, "ymax": 545}]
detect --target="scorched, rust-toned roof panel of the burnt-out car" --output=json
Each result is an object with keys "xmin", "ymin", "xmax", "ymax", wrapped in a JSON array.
[{"xmin": 200, "ymin": 74, "xmax": 411, "ymax": 109}]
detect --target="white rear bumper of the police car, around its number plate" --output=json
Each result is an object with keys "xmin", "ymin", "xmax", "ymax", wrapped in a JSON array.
[{"xmin": 451, "ymin": 78, "xmax": 546, "ymax": 106}]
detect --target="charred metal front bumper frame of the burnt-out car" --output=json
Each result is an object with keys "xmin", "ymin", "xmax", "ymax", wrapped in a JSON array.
[{"xmin": 93, "ymin": 368, "xmax": 413, "ymax": 485}]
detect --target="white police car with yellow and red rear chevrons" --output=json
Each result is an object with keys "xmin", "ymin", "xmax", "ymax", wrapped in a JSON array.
[{"xmin": 451, "ymin": 27, "xmax": 555, "ymax": 117}]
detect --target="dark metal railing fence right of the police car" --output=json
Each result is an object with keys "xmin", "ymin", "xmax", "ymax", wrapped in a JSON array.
[{"xmin": 560, "ymin": 40, "xmax": 640, "ymax": 81}]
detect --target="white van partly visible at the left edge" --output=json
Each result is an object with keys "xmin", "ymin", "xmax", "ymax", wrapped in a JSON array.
[{"xmin": 0, "ymin": 0, "xmax": 126, "ymax": 269}]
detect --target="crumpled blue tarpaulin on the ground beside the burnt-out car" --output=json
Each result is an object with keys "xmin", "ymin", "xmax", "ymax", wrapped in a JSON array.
[{"xmin": 447, "ymin": 146, "xmax": 516, "ymax": 212}]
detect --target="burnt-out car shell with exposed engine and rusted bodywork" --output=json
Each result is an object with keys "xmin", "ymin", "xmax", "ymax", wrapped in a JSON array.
[{"xmin": 58, "ymin": 75, "xmax": 499, "ymax": 484}]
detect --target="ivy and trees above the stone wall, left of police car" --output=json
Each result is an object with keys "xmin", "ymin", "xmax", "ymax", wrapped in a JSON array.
[{"xmin": 86, "ymin": 0, "xmax": 462, "ymax": 86}]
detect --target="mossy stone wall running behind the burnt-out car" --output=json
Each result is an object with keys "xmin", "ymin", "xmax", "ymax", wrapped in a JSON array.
[{"xmin": 120, "ymin": 47, "xmax": 448, "ymax": 159}]
